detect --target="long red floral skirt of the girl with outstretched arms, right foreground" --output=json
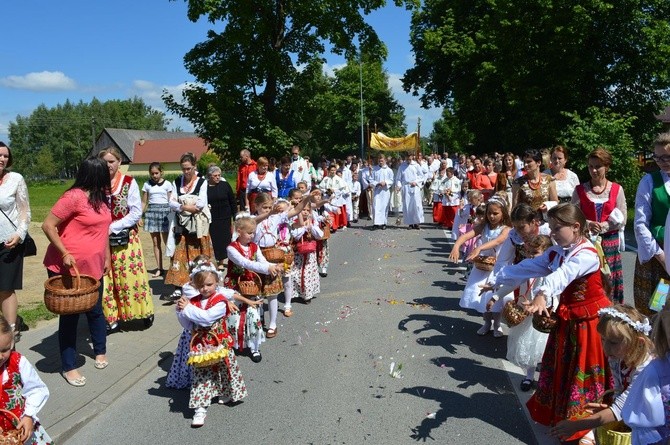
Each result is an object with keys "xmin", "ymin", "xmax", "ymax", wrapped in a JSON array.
[{"xmin": 526, "ymin": 317, "xmax": 614, "ymax": 442}]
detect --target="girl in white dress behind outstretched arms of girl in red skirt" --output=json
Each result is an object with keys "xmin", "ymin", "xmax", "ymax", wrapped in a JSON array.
[{"xmin": 491, "ymin": 232, "xmax": 554, "ymax": 392}]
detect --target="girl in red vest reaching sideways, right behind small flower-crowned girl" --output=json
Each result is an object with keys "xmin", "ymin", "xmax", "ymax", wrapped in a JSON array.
[{"xmin": 224, "ymin": 215, "xmax": 284, "ymax": 363}]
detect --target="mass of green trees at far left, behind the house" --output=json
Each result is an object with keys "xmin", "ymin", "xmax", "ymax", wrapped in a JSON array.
[{"xmin": 9, "ymin": 97, "xmax": 168, "ymax": 177}]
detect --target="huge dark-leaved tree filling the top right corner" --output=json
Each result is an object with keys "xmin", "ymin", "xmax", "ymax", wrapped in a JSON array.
[{"xmin": 403, "ymin": 0, "xmax": 670, "ymax": 150}]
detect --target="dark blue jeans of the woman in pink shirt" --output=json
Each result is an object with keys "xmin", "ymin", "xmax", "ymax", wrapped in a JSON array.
[{"xmin": 47, "ymin": 270, "xmax": 107, "ymax": 372}]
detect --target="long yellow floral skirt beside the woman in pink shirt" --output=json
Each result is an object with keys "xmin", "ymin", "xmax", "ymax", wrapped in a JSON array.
[{"xmin": 102, "ymin": 230, "xmax": 154, "ymax": 324}]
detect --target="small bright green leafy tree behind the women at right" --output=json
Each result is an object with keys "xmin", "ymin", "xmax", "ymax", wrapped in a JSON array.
[{"xmin": 560, "ymin": 107, "xmax": 642, "ymax": 207}]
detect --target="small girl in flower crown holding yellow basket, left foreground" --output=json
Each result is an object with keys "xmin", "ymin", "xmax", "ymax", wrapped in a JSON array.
[{"xmin": 177, "ymin": 263, "xmax": 247, "ymax": 427}]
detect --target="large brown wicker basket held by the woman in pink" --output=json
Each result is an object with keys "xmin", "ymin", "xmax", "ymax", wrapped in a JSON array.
[{"xmin": 44, "ymin": 265, "xmax": 100, "ymax": 315}]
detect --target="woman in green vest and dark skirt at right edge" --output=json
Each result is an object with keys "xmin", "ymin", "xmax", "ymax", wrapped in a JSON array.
[{"xmin": 633, "ymin": 133, "xmax": 670, "ymax": 315}]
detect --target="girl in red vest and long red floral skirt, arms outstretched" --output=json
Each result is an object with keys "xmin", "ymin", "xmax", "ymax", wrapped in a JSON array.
[{"xmin": 483, "ymin": 204, "xmax": 611, "ymax": 440}]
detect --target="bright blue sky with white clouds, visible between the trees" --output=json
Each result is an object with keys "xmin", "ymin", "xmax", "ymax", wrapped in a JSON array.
[{"xmin": 0, "ymin": 0, "xmax": 440, "ymax": 146}]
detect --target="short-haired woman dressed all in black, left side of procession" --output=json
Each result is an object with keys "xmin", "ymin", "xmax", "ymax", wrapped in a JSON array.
[{"xmin": 207, "ymin": 165, "xmax": 237, "ymax": 269}]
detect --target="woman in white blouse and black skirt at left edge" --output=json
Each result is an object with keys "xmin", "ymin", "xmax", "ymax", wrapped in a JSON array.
[{"xmin": 0, "ymin": 142, "xmax": 30, "ymax": 332}]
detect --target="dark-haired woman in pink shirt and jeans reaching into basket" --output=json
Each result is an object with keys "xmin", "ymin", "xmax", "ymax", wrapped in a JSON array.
[{"xmin": 42, "ymin": 158, "xmax": 112, "ymax": 386}]
